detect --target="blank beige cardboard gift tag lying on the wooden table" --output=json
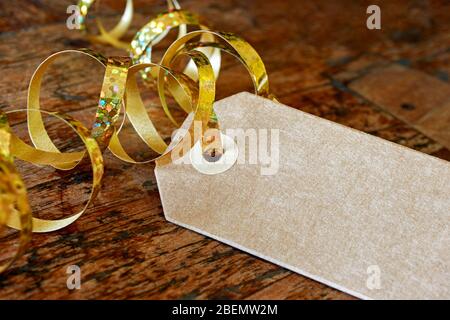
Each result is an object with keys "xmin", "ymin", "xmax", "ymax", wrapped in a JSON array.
[{"xmin": 155, "ymin": 93, "xmax": 450, "ymax": 299}]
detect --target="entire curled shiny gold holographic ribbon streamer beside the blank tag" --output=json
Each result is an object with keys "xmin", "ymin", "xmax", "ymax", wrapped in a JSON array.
[{"xmin": 0, "ymin": 0, "xmax": 274, "ymax": 272}]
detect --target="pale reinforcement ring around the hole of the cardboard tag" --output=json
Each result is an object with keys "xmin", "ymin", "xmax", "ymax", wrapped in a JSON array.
[{"xmin": 189, "ymin": 133, "xmax": 239, "ymax": 175}]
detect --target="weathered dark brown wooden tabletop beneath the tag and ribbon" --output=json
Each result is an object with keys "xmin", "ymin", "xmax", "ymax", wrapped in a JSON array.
[{"xmin": 0, "ymin": 0, "xmax": 450, "ymax": 299}]
